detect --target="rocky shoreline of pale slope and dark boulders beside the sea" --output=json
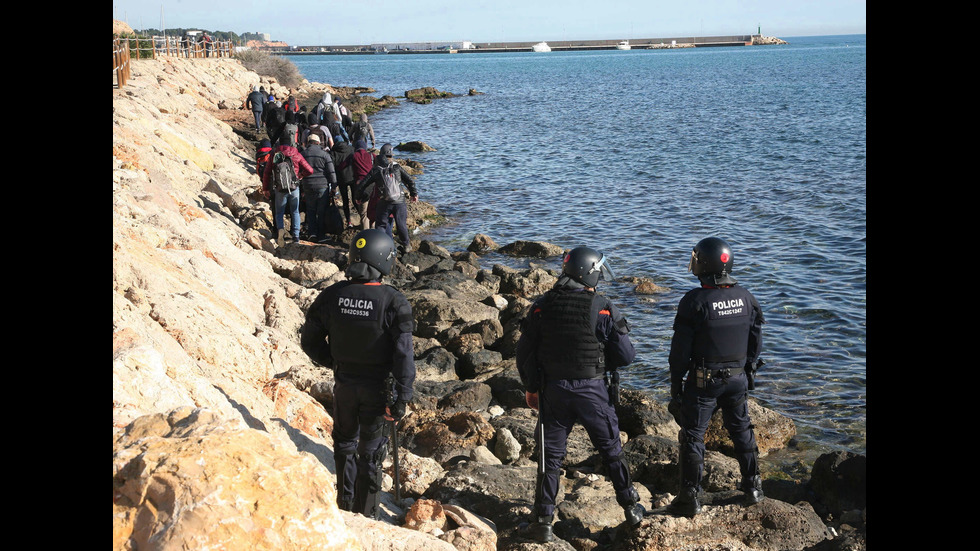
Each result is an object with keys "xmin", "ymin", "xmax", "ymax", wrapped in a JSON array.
[{"xmin": 113, "ymin": 52, "xmax": 866, "ymax": 551}]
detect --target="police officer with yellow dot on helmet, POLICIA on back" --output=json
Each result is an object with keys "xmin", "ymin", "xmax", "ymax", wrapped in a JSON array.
[{"xmin": 300, "ymin": 229, "xmax": 415, "ymax": 519}]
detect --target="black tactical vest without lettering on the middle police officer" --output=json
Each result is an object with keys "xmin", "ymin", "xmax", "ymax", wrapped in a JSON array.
[{"xmin": 537, "ymin": 289, "xmax": 605, "ymax": 380}]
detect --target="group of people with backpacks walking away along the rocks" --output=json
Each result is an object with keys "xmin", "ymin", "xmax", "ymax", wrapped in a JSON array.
[{"xmin": 245, "ymin": 86, "xmax": 418, "ymax": 252}]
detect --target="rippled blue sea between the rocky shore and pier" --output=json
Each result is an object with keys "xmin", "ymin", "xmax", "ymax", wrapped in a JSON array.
[{"xmin": 289, "ymin": 35, "xmax": 867, "ymax": 464}]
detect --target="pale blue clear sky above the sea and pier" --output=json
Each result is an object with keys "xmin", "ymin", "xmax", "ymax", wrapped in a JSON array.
[{"xmin": 112, "ymin": 0, "xmax": 867, "ymax": 46}]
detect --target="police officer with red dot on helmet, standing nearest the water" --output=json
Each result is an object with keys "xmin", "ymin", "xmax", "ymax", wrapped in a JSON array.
[{"xmin": 669, "ymin": 237, "xmax": 765, "ymax": 516}]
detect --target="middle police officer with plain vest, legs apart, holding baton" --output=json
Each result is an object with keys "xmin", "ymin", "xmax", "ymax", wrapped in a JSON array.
[{"xmin": 517, "ymin": 247, "xmax": 645, "ymax": 542}]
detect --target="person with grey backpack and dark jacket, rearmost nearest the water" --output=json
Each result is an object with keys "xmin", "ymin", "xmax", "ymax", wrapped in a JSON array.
[{"xmin": 357, "ymin": 143, "xmax": 419, "ymax": 252}]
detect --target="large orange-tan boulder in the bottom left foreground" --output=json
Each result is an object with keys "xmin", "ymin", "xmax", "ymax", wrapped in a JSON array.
[{"xmin": 112, "ymin": 407, "xmax": 359, "ymax": 551}]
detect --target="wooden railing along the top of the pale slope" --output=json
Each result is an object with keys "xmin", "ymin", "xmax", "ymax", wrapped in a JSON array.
[{"xmin": 112, "ymin": 36, "xmax": 234, "ymax": 88}]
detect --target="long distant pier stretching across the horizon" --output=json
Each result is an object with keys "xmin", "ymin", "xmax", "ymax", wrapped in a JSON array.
[{"xmin": 274, "ymin": 34, "xmax": 764, "ymax": 55}]
